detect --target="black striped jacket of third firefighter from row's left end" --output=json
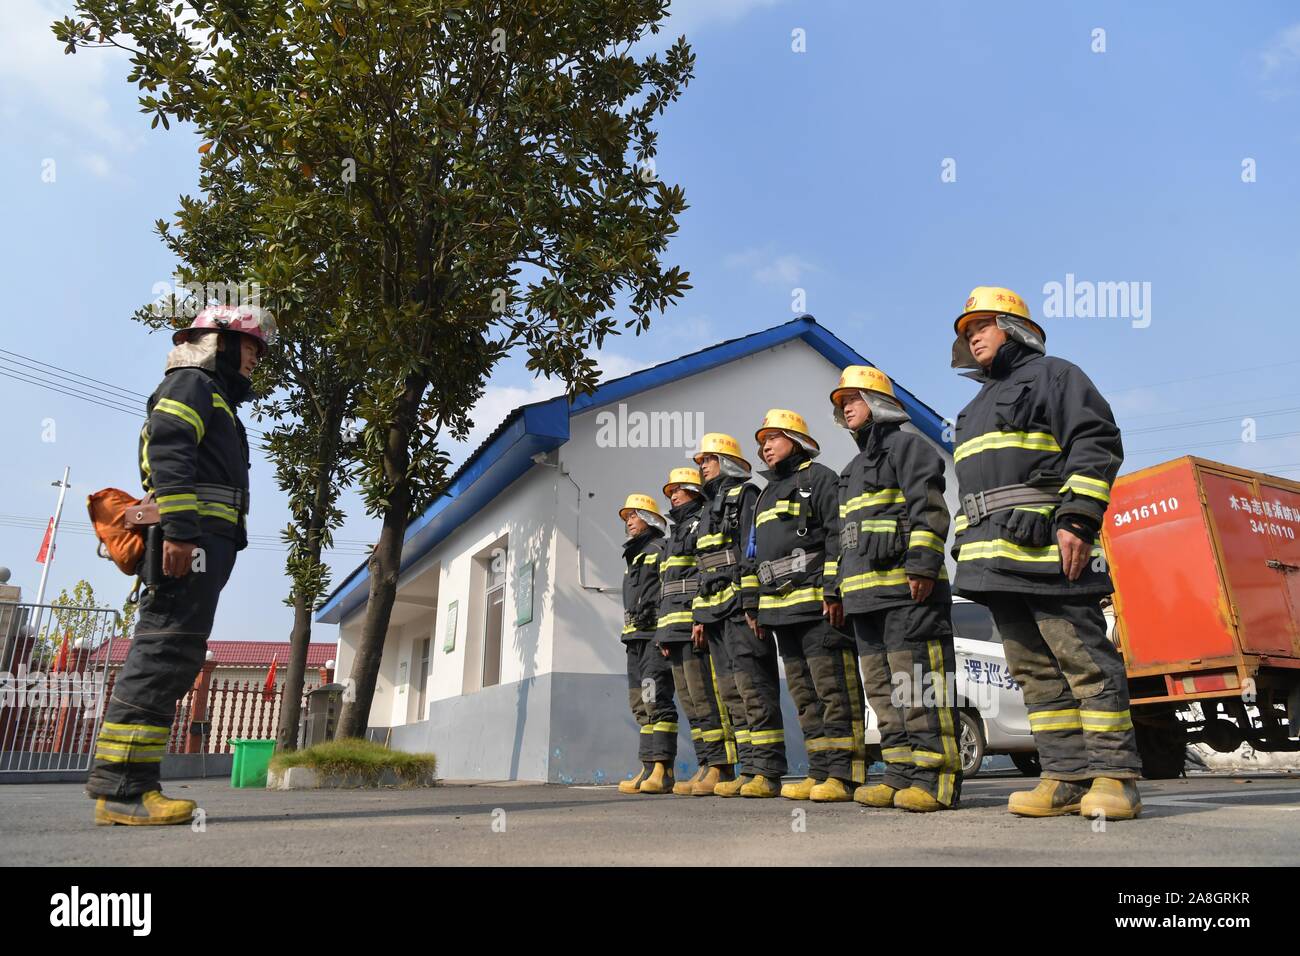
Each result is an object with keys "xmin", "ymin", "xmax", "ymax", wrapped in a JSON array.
[{"xmin": 692, "ymin": 476, "xmax": 758, "ymax": 624}]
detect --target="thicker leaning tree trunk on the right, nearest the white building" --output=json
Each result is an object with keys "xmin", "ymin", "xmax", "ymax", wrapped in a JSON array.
[{"xmin": 338, "ymin": 375, "xmax": 429, "ymax": 739}]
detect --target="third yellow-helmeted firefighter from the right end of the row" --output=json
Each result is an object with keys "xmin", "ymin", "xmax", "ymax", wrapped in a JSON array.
[{"xmin": 748, "ymin": 408, "xmax": 866, "ymax": 803}]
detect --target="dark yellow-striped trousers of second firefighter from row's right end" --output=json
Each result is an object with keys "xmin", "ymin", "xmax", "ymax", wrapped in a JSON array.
[{"xmin": 849, "ymin": 601, "xmax": 962, "ymax": 806}]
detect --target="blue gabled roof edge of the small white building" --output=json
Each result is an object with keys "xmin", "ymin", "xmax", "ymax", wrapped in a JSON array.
[{"xmin": 316, "ymin": 315, "xmax": 952, "ymax": 624}]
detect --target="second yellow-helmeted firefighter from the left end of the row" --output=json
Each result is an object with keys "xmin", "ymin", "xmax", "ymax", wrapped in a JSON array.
[{"xmin": 655, "ymin": 468, "xmax": 736, "ymax": 796}]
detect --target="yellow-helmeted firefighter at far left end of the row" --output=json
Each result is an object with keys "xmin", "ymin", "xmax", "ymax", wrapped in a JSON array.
[{"xmin": 619, "ymin": 494, "xmax": 677, "ymax": 793}]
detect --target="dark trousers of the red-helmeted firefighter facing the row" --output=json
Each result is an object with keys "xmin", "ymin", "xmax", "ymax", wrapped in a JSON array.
[{"xmin": 86, "ymin": 535, "xmax": 235, "ymax": 797}]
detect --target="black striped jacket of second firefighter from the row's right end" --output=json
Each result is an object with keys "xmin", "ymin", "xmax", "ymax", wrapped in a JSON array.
[{"xmin": 836, "ymin": 421, "xmax": 952, "ymax": 614}]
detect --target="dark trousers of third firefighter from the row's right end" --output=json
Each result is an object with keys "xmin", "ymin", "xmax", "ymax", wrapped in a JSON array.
[{"xmin": 770, "ymin": 618, "xmax": 867, "ymax": 783}]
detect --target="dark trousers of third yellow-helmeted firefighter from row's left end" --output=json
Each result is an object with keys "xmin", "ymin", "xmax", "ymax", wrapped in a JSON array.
[{"xmin": 705, "ymin": 614, "xmax": 787, "ymax": 780}]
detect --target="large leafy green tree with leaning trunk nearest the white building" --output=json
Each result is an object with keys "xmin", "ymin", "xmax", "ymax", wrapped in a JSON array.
[{"xmin": 55, "ymin": 0, "xmax": 694, "ymax": 736}]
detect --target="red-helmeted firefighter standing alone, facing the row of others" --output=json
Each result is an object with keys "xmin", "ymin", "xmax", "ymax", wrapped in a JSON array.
[{"xmin": 86, "ymin": 306, "xmax": 274, "ymax": 826}]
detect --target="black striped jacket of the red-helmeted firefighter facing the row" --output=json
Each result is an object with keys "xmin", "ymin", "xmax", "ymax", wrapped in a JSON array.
[{"xmin": 139, "ymin": 367, "xmax": 250, "ymax": 550}]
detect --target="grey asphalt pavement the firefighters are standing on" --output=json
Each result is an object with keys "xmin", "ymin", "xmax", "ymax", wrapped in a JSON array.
[{"xmin": 0, "ymin": 774, "xmax": 1300, "ymax": 866}]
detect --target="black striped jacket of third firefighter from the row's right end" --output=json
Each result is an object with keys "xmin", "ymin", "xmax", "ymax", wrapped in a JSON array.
[{"xmin": 750, "ymin": 450, "xmax": 840, "ymax": 627}]
